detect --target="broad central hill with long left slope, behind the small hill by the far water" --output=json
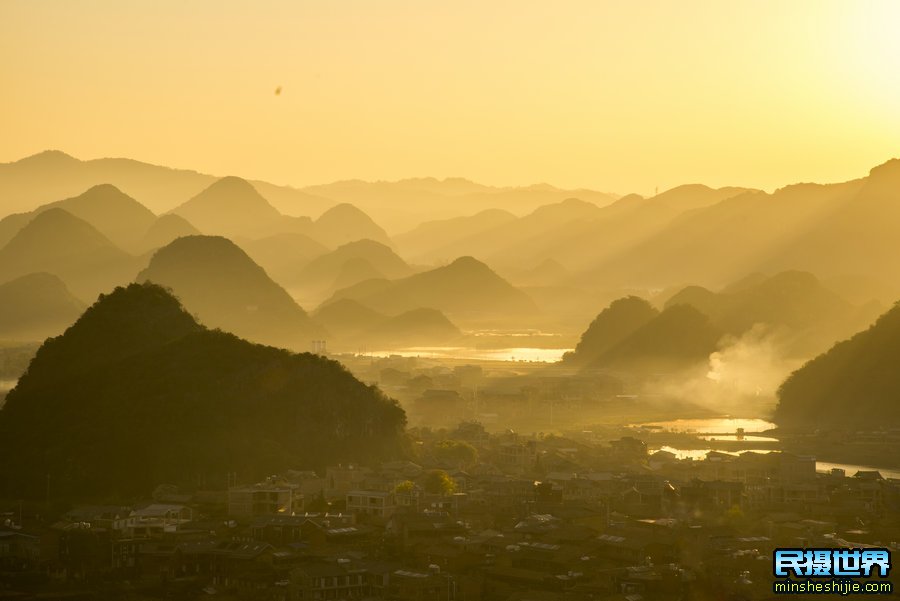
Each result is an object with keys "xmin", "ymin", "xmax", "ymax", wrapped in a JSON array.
[{"xmin": 322, "ymin": 257, "xmax": 537, "ymax": 322}]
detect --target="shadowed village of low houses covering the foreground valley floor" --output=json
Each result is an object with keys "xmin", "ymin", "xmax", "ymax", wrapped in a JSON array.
[{"xmin": 0, "ymin": 422, "xmax": 900, "ymax": 601}]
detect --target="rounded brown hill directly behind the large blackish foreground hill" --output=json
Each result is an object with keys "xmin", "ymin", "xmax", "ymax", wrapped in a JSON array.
[{"xmin": 137, "ymin": 236, "xmax": 322, "ymax": 349}]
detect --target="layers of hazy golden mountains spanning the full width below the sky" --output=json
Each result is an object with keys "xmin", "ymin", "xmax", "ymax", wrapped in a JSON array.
[{"xmin": 0, "ymin": 152, "xmax": 900, "ymax": 356}]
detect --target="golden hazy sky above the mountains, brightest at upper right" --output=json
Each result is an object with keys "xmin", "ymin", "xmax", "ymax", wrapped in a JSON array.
[{"xmin": 0, "ymin": 0, "xmax": 900, "ymax": 193}]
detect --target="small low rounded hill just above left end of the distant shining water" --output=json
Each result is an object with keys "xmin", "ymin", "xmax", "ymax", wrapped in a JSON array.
[{"xmin": 362, "ymin": 308, "xmax": 462, "ymax": 348}]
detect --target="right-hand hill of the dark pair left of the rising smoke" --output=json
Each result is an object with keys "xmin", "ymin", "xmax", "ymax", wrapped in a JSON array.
[{"xmin": 589, "ymin": 305, "xmax": 724, "ymax": 373}]
